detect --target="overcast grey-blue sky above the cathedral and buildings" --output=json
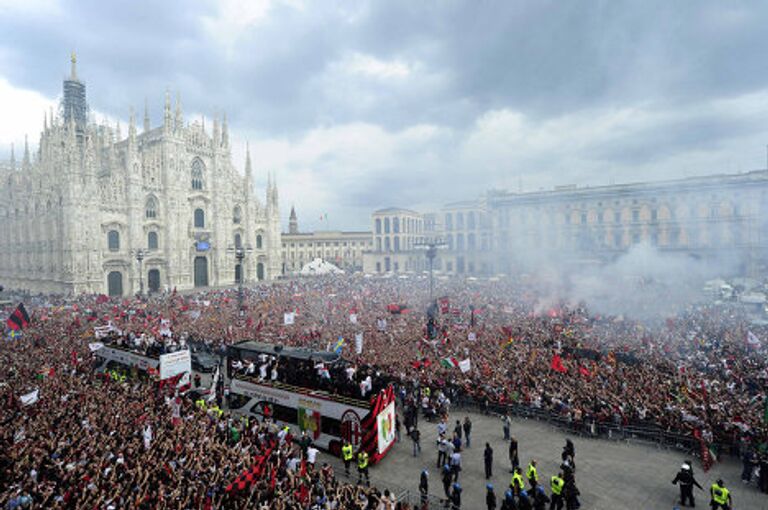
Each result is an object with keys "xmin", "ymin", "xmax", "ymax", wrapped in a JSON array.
[{"xmin": 0, "ymin": 0, "xmax": 768, "ymax": 230}]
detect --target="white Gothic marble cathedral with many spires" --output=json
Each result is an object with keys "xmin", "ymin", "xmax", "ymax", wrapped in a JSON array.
[{"xmin": 0, "ymin": 56, "xmax": 282, "ymax": 296}]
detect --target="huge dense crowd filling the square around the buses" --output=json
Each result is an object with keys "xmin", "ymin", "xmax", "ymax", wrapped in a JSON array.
[{"xmin": 0, "ymin": 270, "xmax": 768, "ymax": 508}]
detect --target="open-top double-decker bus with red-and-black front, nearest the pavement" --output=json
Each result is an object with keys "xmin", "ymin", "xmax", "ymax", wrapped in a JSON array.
[{"xmin": 224, "ymin": 341, "xmax": 395, "ymax": 463}]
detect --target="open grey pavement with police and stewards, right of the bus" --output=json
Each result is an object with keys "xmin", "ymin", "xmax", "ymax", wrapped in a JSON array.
[{"xmin": 320, "ymin": 411, "xmax": 768, "ymax": 510}]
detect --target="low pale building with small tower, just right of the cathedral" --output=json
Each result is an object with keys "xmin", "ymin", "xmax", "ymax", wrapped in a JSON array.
[{"xmin": 281, "ymin": 207, "xmax": 373, "ymax": 275}]
